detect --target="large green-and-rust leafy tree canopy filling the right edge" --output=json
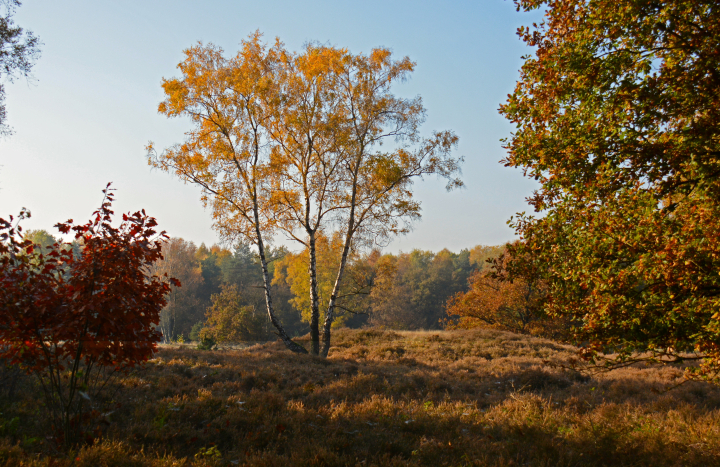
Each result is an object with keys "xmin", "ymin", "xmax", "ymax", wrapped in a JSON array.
[{"xmin": 500, "ymin": 0, "xmax": 720, "ymax": 378}]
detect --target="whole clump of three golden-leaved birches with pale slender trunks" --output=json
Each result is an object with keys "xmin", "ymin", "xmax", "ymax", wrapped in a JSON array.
[{"xmin": 150, "ymin": 33, "xmax": 462, "ymax": 356}]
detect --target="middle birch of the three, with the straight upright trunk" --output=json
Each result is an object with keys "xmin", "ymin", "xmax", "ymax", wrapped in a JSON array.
[{"xmin": 268, "ymin": 44, "xmax": 348, "ymax": 355}]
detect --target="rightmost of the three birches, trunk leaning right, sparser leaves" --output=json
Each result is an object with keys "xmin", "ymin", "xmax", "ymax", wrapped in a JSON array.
[{"xmin": 321, "ymin": 48, "xmax": 463, "ymax": 356}]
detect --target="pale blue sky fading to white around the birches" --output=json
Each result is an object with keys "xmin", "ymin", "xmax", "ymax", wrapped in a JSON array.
[{"xmin": 0, "ymin": 0, "xmax": 540, "ymax": 253}]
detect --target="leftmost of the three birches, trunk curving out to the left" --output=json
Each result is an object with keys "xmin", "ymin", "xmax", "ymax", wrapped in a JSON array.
[{"xmin": 148, "ymin": 33, "xmax": 307, "ymax": 353}]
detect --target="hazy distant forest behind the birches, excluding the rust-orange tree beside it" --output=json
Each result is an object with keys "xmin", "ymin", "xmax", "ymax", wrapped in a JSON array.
[{"xmin": 27, "ymin": 230, "xmax": 503, "ymax": 342}]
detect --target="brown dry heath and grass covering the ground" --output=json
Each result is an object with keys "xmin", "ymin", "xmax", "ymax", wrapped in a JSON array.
[{"xmin": 0, "ymin": 330, "xmax": 720, "ymax": 467}]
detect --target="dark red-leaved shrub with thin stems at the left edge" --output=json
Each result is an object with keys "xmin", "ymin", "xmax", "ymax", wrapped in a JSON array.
[{"xmin": 0, "ymin": 185, "xmax": 174, "ymax": 444}]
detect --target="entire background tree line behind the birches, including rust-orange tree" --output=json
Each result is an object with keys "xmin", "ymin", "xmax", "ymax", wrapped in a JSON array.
[{"xmin": 25, "ymin": 230, "xmax": 558, "ymax": 343}]
